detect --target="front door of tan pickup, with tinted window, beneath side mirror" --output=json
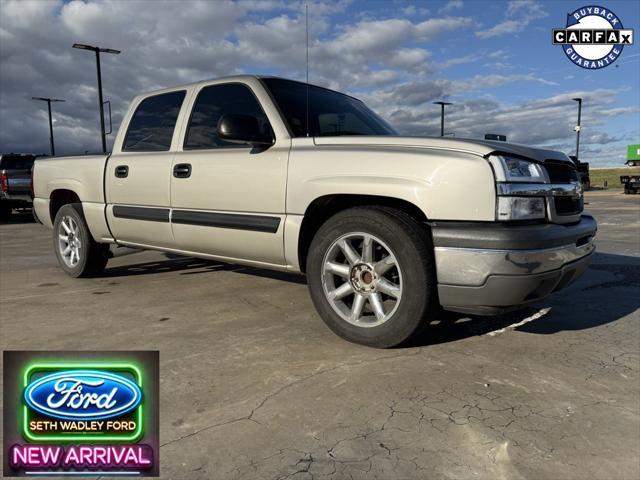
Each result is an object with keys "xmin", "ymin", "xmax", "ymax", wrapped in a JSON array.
[{"xmin": 171, "ymin": 83, "xmax": 290, "ymax": 266}]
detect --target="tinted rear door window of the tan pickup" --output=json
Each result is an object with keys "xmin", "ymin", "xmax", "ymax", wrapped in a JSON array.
[{"xmin": 122, "ymin": 90, "xmax": 185, "ymax": 152}]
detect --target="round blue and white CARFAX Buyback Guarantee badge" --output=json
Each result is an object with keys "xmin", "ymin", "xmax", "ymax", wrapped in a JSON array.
[{"xmin": 553, "ymin": 5, "xmax": 633, "ymax": 69}]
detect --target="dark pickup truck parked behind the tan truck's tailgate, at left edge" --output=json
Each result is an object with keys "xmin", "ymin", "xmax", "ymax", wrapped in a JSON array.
[{"xmin": 0, "ymin": 153, "xmax": 36, "ymax": 220}]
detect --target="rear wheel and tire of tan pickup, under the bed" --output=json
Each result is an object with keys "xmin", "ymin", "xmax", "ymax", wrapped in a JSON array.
[{"xmin": 53, "ymin": 203, "xmax": 109, "ymax": 277}]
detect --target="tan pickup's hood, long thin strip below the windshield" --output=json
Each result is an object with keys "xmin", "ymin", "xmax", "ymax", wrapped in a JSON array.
[{"xmin": 314, "ymin": 135, "xmax": 571, "ymax": 162}]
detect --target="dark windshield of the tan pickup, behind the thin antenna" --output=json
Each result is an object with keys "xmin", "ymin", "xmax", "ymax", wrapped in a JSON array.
[{"xmin": 262, "ymin": 78, "xmax": 397, "ymax": 137}]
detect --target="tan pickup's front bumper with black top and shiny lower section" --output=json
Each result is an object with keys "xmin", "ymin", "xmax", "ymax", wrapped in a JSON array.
[{"xmin": 431, "ymin": 215, "xmax": 597, "ymax": 314}]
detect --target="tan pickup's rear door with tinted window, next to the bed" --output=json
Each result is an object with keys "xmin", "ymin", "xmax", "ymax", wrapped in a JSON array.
[{"xmin": 105, "ymin": 89, "xmax": 187, "ymax": 248}]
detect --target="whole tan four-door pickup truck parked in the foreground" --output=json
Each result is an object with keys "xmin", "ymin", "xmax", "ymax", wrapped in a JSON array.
[{"xmin": 33, "ymin": 76, "xmax": 596, "ymax": 347}]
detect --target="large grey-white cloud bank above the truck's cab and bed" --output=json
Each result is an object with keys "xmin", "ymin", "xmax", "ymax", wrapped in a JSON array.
[{"xmin": 0, "ymin": 0, "xmax": 471, "ymax": 152}]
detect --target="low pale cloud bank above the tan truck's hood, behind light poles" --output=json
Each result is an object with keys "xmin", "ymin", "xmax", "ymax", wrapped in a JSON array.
[{"xmin": 362, "ymin": 86, "xmax": 640, "ymax": 165}]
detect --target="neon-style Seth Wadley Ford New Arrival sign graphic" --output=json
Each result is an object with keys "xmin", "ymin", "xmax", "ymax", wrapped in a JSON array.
[{"xmin": 4, "ymin": 352, "xmax": 158, "ymax": 476}]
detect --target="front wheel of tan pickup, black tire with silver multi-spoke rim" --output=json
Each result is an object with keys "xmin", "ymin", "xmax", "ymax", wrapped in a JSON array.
[{"xmin": 307, "ymin": 207, "xmax": 437, "ymax": 348}]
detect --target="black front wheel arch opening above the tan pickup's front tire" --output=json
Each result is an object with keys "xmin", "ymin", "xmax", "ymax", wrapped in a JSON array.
[{"xmin": 298, "ymin": 194, "xmax": 428, "ymax": 273}]
